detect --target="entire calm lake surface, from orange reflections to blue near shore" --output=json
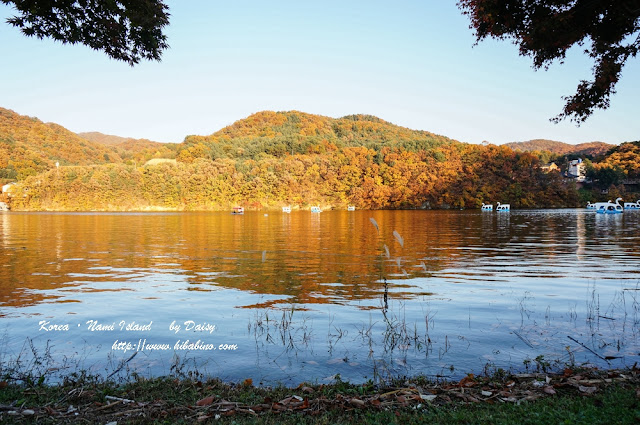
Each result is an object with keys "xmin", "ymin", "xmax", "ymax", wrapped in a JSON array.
[{"xmin": 0, "ymin": 210, "xmax": 640, "ymax": 385}]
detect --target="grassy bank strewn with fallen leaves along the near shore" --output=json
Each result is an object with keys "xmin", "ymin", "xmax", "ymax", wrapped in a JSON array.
[{"xmin": 0, "ymin": 369, "xmax": 640, "ymax": 425}]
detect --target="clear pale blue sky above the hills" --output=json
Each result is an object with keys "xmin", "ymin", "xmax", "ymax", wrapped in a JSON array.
[{"xmin": 0, "ymin": 0, "xmax": 640, "ymax": 144}]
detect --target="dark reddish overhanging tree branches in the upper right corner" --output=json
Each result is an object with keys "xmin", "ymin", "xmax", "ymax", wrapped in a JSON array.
[{"xmin": 458, "ymin": 0, "xmax": 640, "ymax": 124}]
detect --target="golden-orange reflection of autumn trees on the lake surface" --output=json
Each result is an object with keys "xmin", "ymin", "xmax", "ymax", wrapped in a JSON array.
[{"xmin": 0, "ymin": 211, "xmax": 637, "ymax": 308}]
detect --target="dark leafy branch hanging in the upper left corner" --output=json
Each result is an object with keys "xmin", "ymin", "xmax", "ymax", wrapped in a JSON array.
[{"xmin": 0, "ymin": 0, "xmax": 169, "ymax": 66}]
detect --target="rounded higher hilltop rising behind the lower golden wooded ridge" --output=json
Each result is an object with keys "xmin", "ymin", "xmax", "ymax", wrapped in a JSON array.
[{"xmin": 178, "ymin": 111, "xmax": 453, "ymax": 162}]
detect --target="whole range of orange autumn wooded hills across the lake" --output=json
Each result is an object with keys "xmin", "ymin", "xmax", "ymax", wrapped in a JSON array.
[{"xmin": 0, "ymin": 109, "xmax": 640, "ymax": 211}]
